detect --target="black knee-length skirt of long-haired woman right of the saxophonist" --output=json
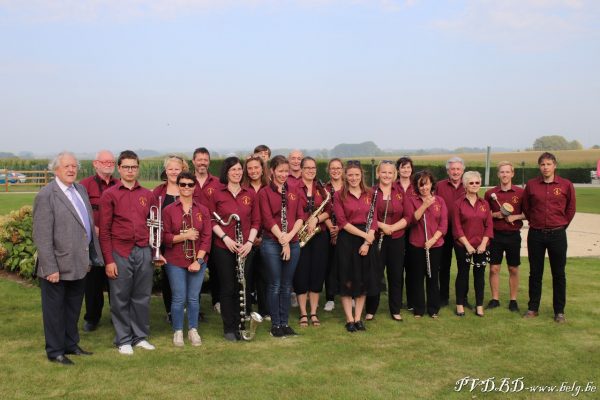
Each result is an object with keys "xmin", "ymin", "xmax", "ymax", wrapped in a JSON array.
[{"xmin": 334, "ymin": 226, "xmax": 381, "ymax": 297}]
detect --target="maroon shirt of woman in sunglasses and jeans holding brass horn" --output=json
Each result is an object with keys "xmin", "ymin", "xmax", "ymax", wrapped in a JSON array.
[{"xmin": 162, "ymin": 200, "xmax": 212, "ymax": 268}]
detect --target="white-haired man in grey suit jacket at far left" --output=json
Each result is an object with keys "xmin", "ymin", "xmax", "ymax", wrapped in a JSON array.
[{"xmin": 33, "ymin": 152, "xmax": 104, "ymax": 365}]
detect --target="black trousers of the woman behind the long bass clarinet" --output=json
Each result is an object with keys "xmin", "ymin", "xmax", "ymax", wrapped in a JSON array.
[{"xmin": 211, "ymin": 246, "xmax": 253, "ymax": 333}]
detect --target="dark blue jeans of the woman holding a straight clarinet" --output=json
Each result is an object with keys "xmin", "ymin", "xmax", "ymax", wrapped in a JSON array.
[{"xmin": 260, "ymin": 237, "xmax": 300, "ymax": 325}]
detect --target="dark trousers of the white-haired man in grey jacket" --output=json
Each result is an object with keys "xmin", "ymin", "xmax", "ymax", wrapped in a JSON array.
[{"xmin": 39, "ymin": 278, "xmax": 85, "ymax": 358}]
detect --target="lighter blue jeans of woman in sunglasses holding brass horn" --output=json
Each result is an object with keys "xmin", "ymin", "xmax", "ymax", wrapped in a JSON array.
[{"xmin": 165, "ymin": 264, "xmax": 206, "ymax": 331}]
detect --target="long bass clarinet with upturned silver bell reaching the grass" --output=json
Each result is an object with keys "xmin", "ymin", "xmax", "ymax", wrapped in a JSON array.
[{"xmin": 213, "ymin": 212, "xmax": 263, "ymax": 340}]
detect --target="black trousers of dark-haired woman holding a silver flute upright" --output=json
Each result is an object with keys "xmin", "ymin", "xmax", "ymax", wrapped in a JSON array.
[{"xmin": 408, "ymin": 245, "xmax": 443, "ymax": 315}]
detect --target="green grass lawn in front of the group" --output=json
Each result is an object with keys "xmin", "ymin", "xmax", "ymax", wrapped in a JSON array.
[{"xmin": 0, "ymin": 258, "xmax": 600, "ymax": 400}]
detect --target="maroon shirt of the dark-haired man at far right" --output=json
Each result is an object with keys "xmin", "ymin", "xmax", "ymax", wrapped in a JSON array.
[{"xmin": 523, "ymin": 175, "xmax": 575, "ymax": 229}]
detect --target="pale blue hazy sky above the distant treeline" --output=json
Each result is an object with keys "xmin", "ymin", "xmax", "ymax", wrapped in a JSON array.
[{"xmin": 0, "ymin": 0, "xmax": 600, "ymax": 154}]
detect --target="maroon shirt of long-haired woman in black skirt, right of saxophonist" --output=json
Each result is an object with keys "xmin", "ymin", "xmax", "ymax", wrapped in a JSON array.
[{"xmin": 333, "ymin": 190, "xmax": 381, "ymax": 231}]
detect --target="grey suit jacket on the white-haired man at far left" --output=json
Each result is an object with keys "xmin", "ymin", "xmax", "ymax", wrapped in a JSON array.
[{"xmin": 33, "ymin": 181, "xmax": 104, "ymax": 281}]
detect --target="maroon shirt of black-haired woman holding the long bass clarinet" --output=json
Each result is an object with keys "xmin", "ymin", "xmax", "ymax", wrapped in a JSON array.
[{"xmin": 208, "ymin": 185, "xmax": 260, "ymax": 249}]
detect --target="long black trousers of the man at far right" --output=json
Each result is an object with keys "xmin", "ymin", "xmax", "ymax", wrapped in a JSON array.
[{"xmin": 527, "ymin": 229, "xmax": 567, "ymax": 314}]
